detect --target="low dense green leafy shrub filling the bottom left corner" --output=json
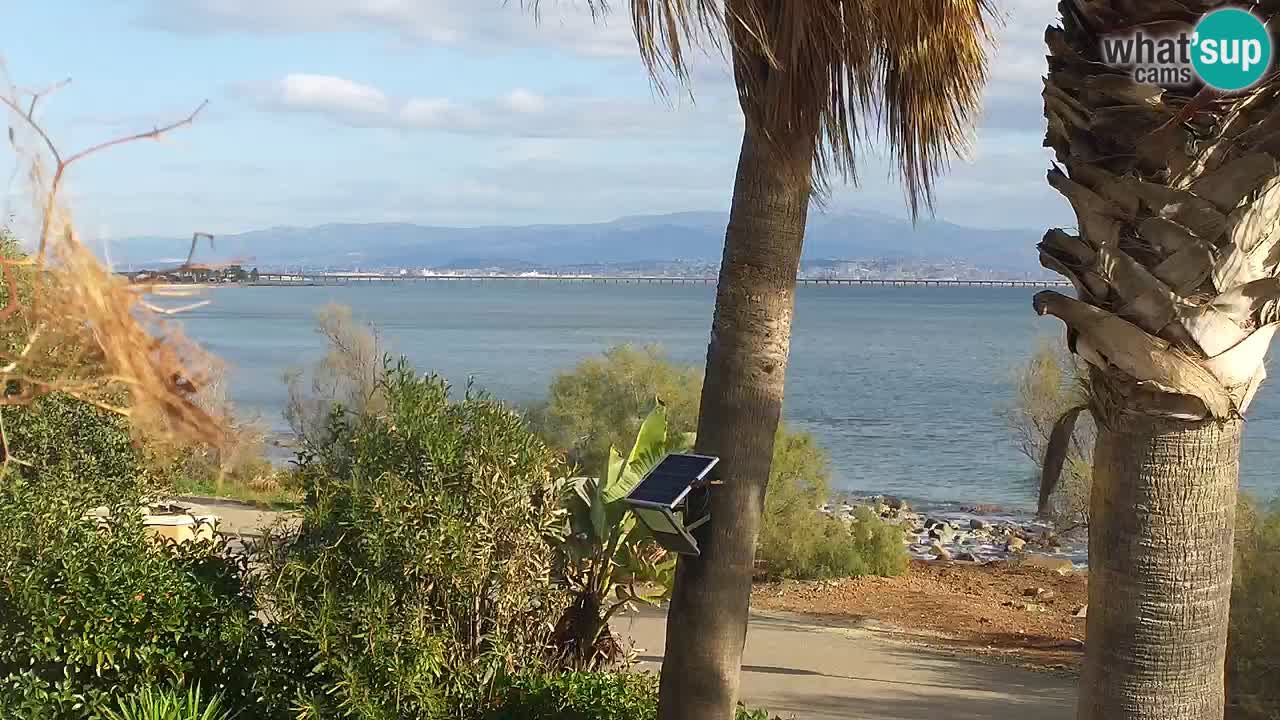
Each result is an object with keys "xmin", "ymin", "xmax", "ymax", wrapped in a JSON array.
[{"xmin": 0, "ymin": 475, "xmax": 273, "ymax": 720}]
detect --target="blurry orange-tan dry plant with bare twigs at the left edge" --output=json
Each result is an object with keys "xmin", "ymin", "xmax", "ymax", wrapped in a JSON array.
[{"xmin": 0, "ymin": 71, "xmax": 224, "ymax": 453}]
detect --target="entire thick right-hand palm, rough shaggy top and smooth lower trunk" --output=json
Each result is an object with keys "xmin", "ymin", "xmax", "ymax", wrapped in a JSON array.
[{"xmin": 1036, "ymin": 0, "xmax": 1280, "ymax": 720}]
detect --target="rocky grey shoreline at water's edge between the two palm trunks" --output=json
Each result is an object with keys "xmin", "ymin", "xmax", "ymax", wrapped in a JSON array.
[{"xmin": 822, "ymin": 495, "xmax": 1089, "ymax": 571}]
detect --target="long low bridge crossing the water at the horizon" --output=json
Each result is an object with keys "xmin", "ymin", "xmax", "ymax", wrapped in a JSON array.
[{"xmin": 253, "ymin": 273, "xmax": 1070, "ymax": 287}]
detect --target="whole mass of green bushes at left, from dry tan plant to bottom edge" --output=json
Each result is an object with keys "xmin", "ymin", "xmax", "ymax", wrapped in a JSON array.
[{"xmin": 0, "ymin": 393, "xmax": 296, "ymax": 720}]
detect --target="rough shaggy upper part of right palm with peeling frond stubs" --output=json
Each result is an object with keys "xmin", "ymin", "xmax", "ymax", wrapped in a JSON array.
[{"xmin": 1036, "ymin": 0, "xmax": 1280, "ymax": 424}]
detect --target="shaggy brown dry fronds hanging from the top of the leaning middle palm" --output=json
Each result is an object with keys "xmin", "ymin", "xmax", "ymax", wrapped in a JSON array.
[{"xmin": 525, "ymin": 0, "xmax": 995, "ymax": 214}]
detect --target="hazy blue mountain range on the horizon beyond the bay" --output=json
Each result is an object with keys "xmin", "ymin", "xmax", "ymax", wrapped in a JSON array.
[{"xmin": 105, "ymin": 210, "xmax": 1041, "ymax": 273}]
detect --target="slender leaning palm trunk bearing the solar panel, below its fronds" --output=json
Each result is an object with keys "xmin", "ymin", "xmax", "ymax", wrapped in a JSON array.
[{"xmin": 658, "ymin": 123, "xmax": 812, "ymax": 720}]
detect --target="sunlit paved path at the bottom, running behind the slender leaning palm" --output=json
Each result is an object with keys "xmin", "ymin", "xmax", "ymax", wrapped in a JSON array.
[{"xmin": 614, "ymin": 604, "xmax": 1075, "ymax": 720}]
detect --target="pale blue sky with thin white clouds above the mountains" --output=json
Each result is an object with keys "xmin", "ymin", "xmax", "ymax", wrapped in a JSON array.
[{"xmin": 0, "ymin": 0, "xmax": 1071, "ymax": 240}]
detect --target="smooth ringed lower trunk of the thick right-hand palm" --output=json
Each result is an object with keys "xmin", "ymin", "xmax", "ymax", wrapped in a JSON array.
[{"xmin": 1078, "ymin": 376, "xmax": 1242, "ymax": 720}]
